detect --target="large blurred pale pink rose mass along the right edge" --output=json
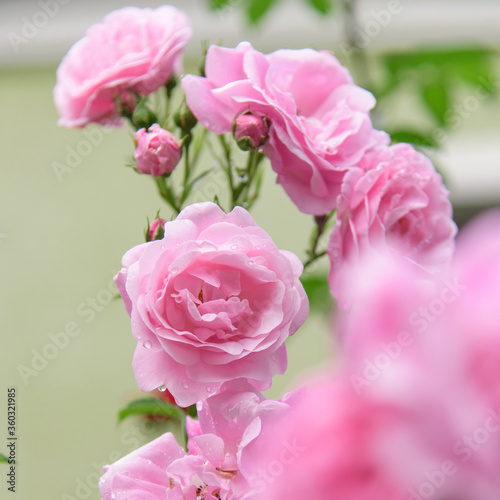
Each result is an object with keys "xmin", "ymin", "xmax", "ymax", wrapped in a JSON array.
[{"xmin": 339, "ymin": 210, "xmax": 500, "ymax": 500}]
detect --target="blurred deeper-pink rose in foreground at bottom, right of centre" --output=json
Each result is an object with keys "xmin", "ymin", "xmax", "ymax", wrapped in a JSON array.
[{"xmin": 257, "ymin": 377, "xmax": 408, "ymax": 500}]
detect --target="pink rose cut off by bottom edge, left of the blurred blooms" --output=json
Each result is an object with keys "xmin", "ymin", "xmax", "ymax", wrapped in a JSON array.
[{"xmin": 99, "ymin": 433, "xmax": 228, "ymax": 500}]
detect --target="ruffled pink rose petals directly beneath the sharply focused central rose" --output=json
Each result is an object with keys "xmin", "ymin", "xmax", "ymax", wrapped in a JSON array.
[{"xmin": 188, "ymin": 380, "xmax": 301, "ymax": 500}]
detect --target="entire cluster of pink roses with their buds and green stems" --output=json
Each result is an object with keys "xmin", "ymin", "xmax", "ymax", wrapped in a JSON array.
[{"xmin": 54, "ymin": 6, "xmax": 500, "ymax": 500}]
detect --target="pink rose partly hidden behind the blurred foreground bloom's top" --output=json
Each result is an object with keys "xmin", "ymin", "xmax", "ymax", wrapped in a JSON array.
[{"xmin": 328, "ymin": 144, "xmax": 456, "ymax": 307}]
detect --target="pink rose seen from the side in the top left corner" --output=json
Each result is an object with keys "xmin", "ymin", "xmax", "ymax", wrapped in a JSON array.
[{"xmin": 54, "ymin": 6, "xmax": 191, "ymax": 127}]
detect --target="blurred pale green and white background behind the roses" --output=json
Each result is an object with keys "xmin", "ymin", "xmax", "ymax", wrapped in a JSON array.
[{"xmin": 0, "ymin": 0, "xmax": 500, "ymax": 500}]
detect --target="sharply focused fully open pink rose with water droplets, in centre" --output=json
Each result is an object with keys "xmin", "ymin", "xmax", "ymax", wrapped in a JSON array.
[{"xmin": 115, "ymin": 203, "xmax": 309, "ymax": 406}]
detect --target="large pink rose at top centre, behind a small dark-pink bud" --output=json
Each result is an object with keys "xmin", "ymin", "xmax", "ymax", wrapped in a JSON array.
[{"xmin": 183, "ymin": 42, "xmax": 388, "ymax": 215}]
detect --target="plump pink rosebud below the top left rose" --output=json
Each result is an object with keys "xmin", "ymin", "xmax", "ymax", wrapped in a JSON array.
[{"xmin": 134, "ymin": 123, "xmax": 182, "ymax": 177}]
